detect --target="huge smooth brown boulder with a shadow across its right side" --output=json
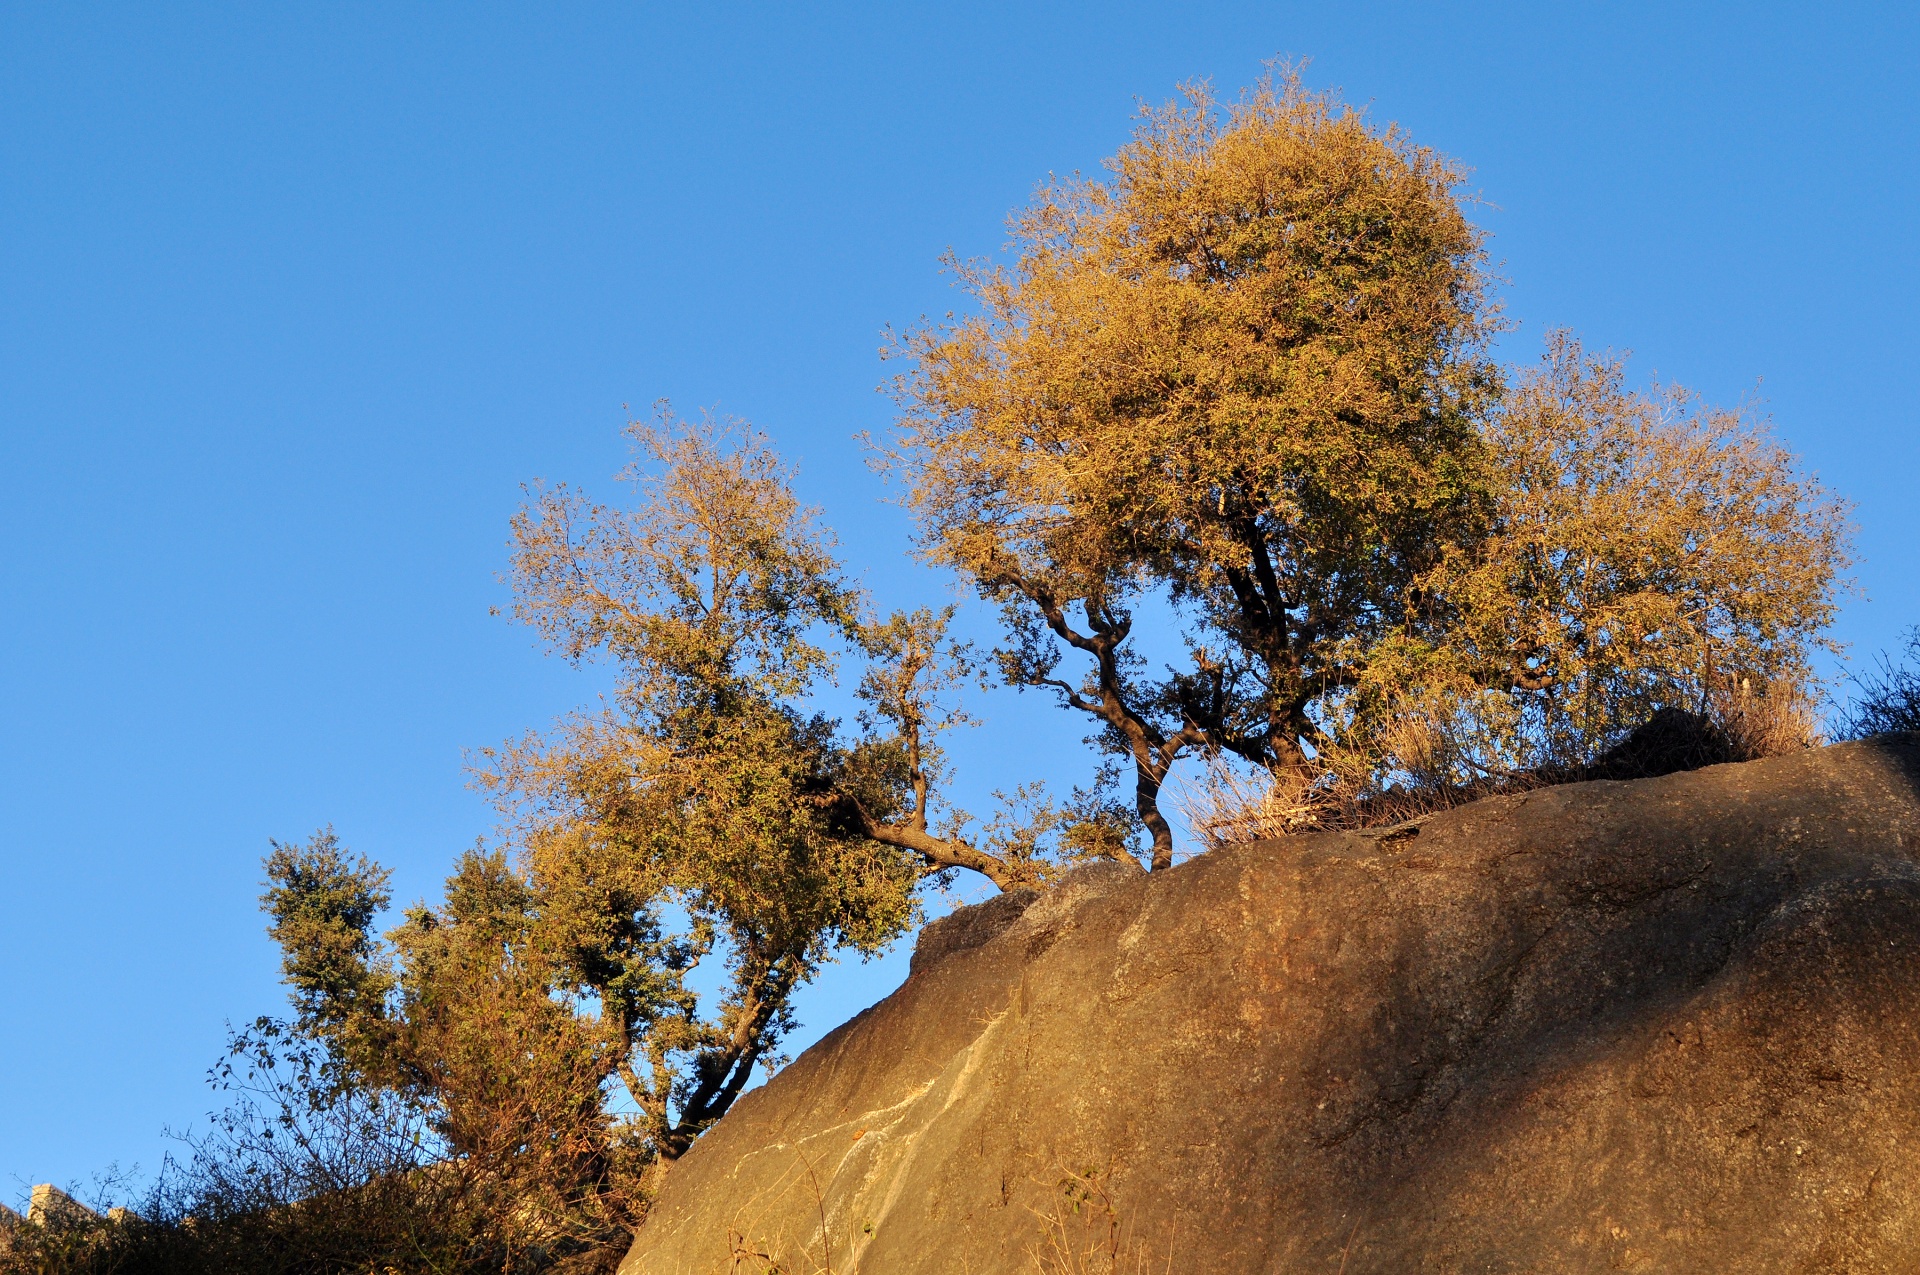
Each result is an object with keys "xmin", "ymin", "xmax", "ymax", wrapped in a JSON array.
[{"xmin": 620, "ymin": 735, "xmax": 1920, "ymax": 1275}]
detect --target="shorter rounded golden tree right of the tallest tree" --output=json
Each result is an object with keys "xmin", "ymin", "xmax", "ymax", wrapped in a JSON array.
[{"xmin": 1420, "ymin": 332, "xmax": 1849, "ymax": 776}]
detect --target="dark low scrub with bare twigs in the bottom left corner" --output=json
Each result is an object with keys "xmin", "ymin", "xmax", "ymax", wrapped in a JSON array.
[{"xmin": 0, "ymin": 1020, "xmax": 556, "ymax": 1275}]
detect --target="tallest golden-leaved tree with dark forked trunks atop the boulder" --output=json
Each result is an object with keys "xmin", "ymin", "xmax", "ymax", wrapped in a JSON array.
[{"xmin": 893, "ymin": 73, "xmax": 1500, "ymax": 868}]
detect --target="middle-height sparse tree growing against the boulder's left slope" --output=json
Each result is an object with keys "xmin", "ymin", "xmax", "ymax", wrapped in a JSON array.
[{"xmin": 480, "ymin": 413, "xmax": 918, "ymax": 1160}]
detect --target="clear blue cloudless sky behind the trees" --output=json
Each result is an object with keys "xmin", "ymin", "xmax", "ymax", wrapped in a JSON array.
[{"xmin": 0, "ymin": 2, "xmax": 1920, "ymax": 1198}]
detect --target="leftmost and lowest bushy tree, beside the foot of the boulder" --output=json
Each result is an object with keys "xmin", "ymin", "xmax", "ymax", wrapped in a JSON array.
[{"xmin": 266, "ymin": 831, "xmax": 651, "ymax": 1267}]
